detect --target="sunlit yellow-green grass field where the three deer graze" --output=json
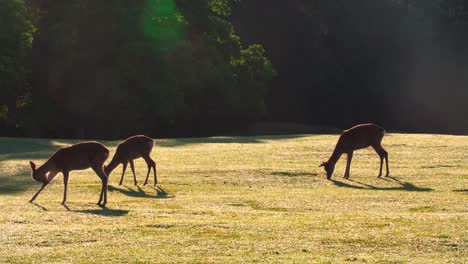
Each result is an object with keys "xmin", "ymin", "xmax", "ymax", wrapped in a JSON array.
[{"xmin": 0, "ymin": 134, "xmax": 468, "ymax": 263}]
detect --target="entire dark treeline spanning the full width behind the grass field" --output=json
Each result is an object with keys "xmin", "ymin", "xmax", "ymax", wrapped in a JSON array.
[{"xmin": 0, "ymin": 0, "xmax": 468, "ymax": 138}]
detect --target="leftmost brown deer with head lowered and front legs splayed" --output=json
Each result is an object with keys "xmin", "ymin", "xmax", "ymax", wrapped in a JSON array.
[{"xmin": 30, "ymin": 142, "xmax": 109, "ymax": 206}]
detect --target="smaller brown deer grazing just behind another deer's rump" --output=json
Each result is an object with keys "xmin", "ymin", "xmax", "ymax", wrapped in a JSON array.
[{"xmin": 104, "ymin": 135, "xmax": 158, "ymax": 185}]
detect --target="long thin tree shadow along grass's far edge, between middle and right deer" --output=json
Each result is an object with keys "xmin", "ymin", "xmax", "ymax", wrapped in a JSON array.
[{"xmin": 156, "ymin": 135, "xmax": 306, "ymax": 147}]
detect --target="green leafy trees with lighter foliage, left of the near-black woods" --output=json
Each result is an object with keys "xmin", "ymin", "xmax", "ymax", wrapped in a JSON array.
[{"xmin": 0, "ymin": 0, "xmax": 275, "ymax": 138}]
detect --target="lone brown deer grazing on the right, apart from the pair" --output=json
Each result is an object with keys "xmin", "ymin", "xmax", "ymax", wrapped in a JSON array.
[{"xmin": 320, "ymin": 124, "xmax": 390, "ymax": 179}]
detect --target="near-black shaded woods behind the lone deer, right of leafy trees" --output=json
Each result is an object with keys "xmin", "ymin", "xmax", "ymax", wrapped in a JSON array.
[{"xmin": 233, "ymin": 0, "xmax": 468, "ymax": 133}]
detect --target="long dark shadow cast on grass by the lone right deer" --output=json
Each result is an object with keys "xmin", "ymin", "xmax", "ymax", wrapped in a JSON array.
[{"xmin": 331, "ymin": 176, "xmax": 434, "ymax": 192}]
